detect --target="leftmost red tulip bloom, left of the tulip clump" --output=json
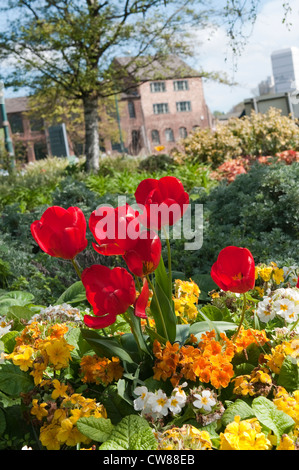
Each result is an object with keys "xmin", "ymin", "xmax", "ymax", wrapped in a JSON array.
[{"xmin": 31, "ymin": 206, "xmax": 88, "ymax": 259}]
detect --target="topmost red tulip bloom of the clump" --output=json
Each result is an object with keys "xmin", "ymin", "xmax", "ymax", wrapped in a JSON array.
[{"xmin": 135, "ymin": 176, "xmax": 189, "ymax": 230}]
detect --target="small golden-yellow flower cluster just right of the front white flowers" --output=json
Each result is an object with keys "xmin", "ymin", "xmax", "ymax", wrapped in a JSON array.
[{"xmin": 233, "ymin": 368, "xmax": 272, "ymax": 397}]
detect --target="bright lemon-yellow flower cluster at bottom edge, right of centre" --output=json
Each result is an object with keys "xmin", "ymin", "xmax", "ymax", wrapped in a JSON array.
[{"xmin": 220, "ymin": 416, "xmax": 272, "ymax": 450}]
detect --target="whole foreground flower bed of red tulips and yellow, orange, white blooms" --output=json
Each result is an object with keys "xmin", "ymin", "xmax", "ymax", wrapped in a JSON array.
[{"xmin": 0, "ymin": 177, "xmax": 299, "ymax": 451}]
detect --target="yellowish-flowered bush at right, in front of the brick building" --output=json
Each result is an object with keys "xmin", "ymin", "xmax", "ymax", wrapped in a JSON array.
[{"xmin": 178, "ymin": 108, "xmax": 299, "ymax": 168}]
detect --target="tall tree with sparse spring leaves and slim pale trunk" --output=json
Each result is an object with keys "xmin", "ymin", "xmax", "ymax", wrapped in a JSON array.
[{"xmin": 0, "ymin": 0, "xmax": 268, "ymax": 171}]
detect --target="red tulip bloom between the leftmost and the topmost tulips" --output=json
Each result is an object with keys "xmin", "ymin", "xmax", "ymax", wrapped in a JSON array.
[{"xmin": 89, "ymin": 204, "xmax": 139, "ymax": 256}]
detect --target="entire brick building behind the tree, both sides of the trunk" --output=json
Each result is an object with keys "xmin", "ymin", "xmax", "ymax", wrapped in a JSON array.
[{"xmin": 5, "ymin": 56, "xmax": 213, "ymax": 162}]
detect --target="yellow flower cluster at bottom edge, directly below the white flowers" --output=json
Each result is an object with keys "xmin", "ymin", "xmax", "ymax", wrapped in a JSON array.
[{"xmin": 156, "ymin": 424, "xmax": 212, "ymax": 450}]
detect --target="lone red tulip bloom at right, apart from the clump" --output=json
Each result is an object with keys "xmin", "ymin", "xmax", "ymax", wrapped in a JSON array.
[{"xmin": 211, "ymin": 246, "xmax": 255, "ymax": 294}]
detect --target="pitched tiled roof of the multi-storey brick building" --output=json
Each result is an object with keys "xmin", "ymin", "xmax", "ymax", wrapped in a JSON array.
[{"xmin": 114, "ymin": 55, "xmax": 201, "ymax": 81}]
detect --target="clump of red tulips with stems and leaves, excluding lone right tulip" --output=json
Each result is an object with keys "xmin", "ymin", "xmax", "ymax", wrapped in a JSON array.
[{"xmin": 31, "ymin": 177, "xmax": 189, "ymax": 374}]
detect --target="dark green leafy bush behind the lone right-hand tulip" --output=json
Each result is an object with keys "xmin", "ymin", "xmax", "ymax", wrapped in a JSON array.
[{"xmin": 172, "ymin": 163, "xmax": 299, "ymax": 276}]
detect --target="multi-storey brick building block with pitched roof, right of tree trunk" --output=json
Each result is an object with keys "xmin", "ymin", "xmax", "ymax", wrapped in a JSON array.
[{"xmin": 110, "ymin": 56, "xmax": 212, "ymax": 155}]
